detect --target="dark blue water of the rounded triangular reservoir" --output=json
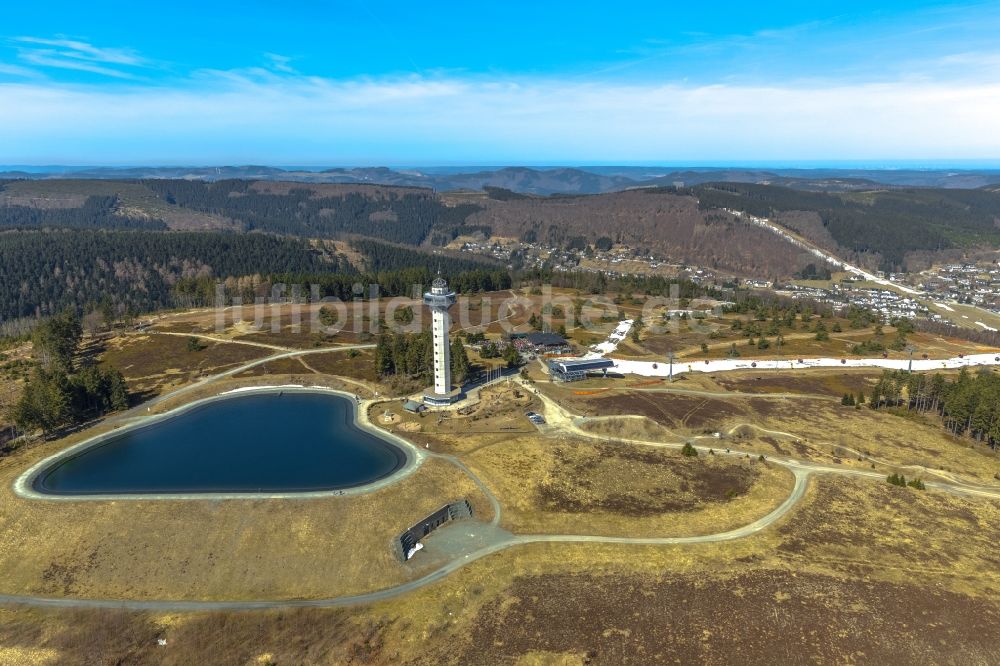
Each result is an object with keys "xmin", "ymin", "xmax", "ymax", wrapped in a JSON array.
[{"xmin": 34, "ymin": 392, "xmax": 406, "ymax": 495}]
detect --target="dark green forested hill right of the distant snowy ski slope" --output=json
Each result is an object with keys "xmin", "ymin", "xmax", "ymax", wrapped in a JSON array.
[{"xmin": 682, "ymin": 183, "xmax": 1000, "ymax": 270}]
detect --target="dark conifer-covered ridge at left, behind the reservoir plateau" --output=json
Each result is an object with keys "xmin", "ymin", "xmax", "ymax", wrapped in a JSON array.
[{"xmin": 0, "ymin": 230, "xmax": 510, "ymax": 323}]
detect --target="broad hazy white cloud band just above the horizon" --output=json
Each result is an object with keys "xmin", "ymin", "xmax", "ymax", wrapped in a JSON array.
[{"xmin": 0, "ymin": 74, "xmax": 1000, "ymax": 163}]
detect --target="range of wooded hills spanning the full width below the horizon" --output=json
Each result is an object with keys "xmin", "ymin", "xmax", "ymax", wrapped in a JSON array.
[{"xmin": 0, "ymin": 179, "xmax": 1000, "ymax": 279}]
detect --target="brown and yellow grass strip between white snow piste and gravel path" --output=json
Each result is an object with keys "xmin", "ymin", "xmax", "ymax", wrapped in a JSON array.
[{"xmin": 538, "ymin": 373, "xmax": 1000, "ymax": 483}]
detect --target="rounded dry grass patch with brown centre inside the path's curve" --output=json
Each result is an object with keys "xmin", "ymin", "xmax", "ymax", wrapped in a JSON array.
[{"xmin": 463, "ymin": 435, "xmax": 792, "ymax": 536}]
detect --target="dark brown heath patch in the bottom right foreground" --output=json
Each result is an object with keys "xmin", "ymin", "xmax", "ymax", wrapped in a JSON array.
[{"xmin": 460, "ymin": 571, "xmax": 1000, "ymax": 664}]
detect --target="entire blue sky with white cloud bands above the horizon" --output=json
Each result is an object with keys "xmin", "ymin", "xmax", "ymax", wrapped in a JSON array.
[{"xmin": 0, "ymin": 0, "xmax": 1000, "ymax": 165}]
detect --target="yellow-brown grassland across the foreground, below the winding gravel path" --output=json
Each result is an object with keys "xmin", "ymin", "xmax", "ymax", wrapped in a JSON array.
[{"xmin": 0, "ymin": 477, "xmax": 1000, "ymax": 664}]
